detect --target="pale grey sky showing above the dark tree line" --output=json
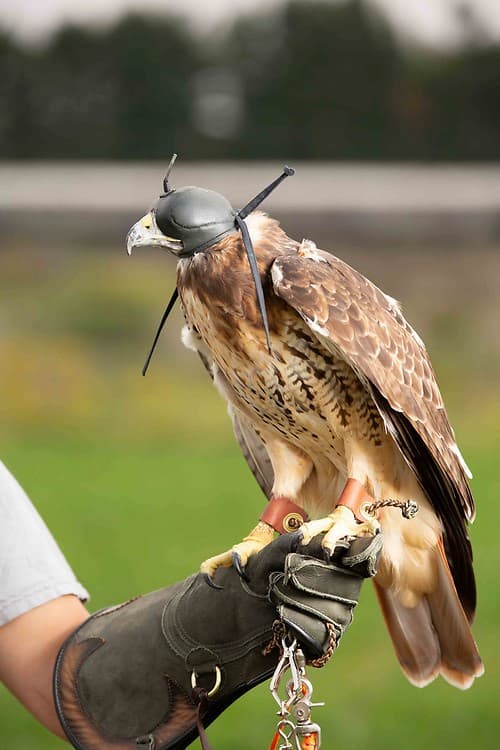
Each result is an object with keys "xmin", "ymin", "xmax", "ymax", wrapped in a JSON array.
[{"xmin": 0, "ymin": 0, "xmax": 500, "ymax": 44}]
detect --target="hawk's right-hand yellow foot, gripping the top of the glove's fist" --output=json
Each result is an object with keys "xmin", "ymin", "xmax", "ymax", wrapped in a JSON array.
[{"xmin": 300, "ymin": 505, "xmax": 380, "ymax": 555}]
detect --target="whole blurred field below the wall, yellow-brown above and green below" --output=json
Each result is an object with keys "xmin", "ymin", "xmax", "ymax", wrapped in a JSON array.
[{"xmin": 0, "ymin": 245, "xmax": 500, "ymax": 750}]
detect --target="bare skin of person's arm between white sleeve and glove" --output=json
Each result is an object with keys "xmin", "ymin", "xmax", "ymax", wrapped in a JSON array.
[{"xmin": 0, "ymin": 595, "xmax": 89, "ymax": 739}]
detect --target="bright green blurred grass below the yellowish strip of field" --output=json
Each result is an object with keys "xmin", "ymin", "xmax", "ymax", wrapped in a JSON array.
[{"xmin": 0, "ymin": 428, "xmax": 500, "ymax": 750}]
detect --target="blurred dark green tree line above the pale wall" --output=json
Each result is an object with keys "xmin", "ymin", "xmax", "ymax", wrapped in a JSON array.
[{"xmin": 0, "ymin": 0, "xmax": 500, "ymax": 161}]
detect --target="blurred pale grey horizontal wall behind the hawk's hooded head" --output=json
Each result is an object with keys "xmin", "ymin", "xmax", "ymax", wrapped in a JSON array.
[{"xmin": 0, "ymin": 161, "xmax": 500, "ymax": 246}]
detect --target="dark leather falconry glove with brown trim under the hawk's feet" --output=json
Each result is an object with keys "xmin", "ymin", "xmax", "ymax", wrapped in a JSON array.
[{"xmin": 54, "ymin": 534, "xmax": 382, "ymax": 750}]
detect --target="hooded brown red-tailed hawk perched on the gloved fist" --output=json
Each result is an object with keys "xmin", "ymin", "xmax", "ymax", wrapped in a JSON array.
[{"xmin": 128, "ymin": 166, "xmax": 483, "ymax": 688}]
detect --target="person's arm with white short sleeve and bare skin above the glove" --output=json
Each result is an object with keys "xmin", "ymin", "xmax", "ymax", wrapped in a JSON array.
[{"xmin": 0, "ymin": 461, "xmax": 88, "ymax": 737}]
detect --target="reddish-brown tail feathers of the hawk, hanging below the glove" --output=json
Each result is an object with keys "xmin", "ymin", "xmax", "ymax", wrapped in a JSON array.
[{"xmin": 374, "ymin": 543, "xmax": 484, "ymax": 690}]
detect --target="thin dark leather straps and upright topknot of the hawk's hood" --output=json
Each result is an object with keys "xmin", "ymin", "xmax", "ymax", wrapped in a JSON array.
[{"xmin": 142, "ymin": 164, "xmax": 295, "ymax": 375}]
